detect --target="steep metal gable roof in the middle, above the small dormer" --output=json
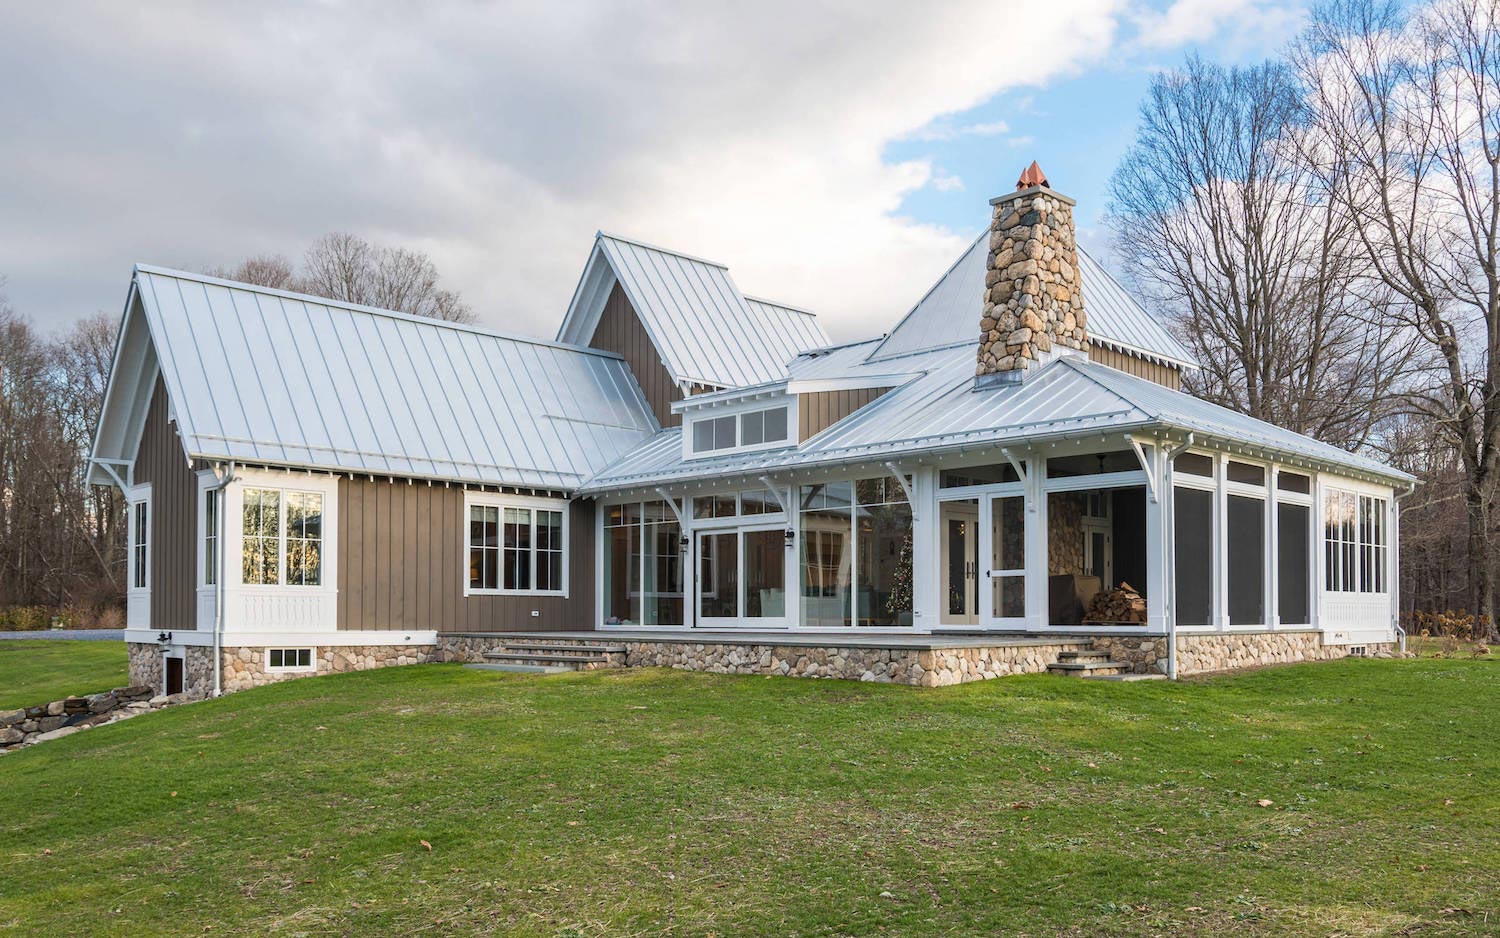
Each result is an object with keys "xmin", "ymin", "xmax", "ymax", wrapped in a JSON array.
[{"xmin": 558, "ymin": 231, "xmax": 828, "ymax": 387}]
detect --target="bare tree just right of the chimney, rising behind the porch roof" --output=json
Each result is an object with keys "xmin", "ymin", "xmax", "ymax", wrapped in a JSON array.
[{"xmin": 1110, "ymin": 57, "xmax": 1413, "ymax": 449}]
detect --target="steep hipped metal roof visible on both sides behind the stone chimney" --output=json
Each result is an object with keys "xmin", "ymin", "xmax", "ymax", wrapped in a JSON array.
[{"xmin": 870, "ymin": 231, "xmax": 1194, "ymax": 365}]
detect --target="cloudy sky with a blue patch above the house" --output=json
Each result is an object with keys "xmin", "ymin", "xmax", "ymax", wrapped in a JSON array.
[{"xmin": 0, "ymin": 0, "xmax": 1304, "ymax": 339}]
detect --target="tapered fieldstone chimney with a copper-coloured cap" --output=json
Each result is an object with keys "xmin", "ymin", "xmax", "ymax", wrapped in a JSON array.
[{"xmin": 975, "ymin": 162, "xmax": 1089, "ymax": 384}]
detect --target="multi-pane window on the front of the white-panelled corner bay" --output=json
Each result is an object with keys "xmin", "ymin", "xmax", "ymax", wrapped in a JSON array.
[{"xmin": 240, "ymin": 489, "xmax": 323, "ymax": 587}]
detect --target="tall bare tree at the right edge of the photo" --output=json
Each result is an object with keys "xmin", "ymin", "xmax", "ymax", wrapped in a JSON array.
[{"xmin": 1293, "ymin": 0, "xmax": 1500, "ymax": 639}]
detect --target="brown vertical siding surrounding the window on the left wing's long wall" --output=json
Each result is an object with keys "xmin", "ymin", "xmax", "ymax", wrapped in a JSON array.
[{"xmin": 338, "ymin": 479, "xmax": 594, "ymax": 632}]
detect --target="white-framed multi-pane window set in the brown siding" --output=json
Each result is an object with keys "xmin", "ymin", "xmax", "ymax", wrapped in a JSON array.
[{"xmin": 468, "ymin": 504, "xmax": 567, "ymax": 593}]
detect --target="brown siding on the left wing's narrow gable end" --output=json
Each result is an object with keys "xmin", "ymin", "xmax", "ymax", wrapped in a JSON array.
[{"xmin": 135, "ymin": 377, "xmax": 198, "ymax": 632}]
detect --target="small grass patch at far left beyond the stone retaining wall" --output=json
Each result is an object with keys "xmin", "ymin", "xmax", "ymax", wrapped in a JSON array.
[{"xmin": 0, "ymin": 639, "xmax": 126, "ymax": 710}]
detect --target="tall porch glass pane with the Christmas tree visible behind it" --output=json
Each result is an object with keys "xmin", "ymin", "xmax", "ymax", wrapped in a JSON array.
[{"xmin": 855, "ymin": 477, "xmax": 912, "ymax": 627}]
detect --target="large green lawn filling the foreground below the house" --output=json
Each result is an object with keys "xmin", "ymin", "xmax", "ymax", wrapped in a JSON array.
[{"xmin": 0, "ymin": 660, "xmax": 1500, "ymax": 936}]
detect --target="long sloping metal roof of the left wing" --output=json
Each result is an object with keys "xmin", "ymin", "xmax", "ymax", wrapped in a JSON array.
[{"xmin": 96, "ymin": 259, "xmax": 657, "ymax": 489}]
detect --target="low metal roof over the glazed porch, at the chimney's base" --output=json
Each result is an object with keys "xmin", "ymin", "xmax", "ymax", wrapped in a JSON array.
[{"xmin": 582, "ymin": 347, "xmax": 1412, "ymax": 492}]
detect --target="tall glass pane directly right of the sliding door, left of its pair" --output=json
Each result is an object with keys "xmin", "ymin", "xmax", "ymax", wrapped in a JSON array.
[{"xmin": 798, "ymin": 482, "xmax": 854, "ymax": 629}]
